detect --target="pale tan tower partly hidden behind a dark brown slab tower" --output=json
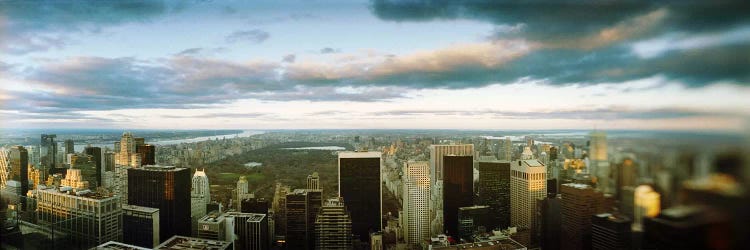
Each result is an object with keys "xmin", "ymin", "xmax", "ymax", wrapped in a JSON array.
[{"xmin": 430, "ymin": 144, "xmax": 474, "ymax": 235}]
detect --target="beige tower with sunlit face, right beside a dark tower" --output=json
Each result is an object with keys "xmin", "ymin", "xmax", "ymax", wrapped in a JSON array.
[{"xmin": 510, "ymin": 160, "xmax": 547, "ymax": 229}]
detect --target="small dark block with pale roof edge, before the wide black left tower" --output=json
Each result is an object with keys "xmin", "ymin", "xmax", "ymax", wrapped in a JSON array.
[{"xmin": 122, "ymin": 204, "xmax": 161, "ymax": 248}]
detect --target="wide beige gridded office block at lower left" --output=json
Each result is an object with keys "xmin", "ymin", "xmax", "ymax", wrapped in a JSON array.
[{"xmin": 36, "ymin": 185, "xmax": 122, "ymax": 249}]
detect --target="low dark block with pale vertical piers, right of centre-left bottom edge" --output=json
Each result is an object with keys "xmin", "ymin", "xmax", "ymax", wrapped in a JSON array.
[{"xmin": 224, "ymin": 212, "xmax": 270, "ymax": 250}]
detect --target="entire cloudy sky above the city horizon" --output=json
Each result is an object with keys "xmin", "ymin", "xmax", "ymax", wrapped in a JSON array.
[{"xmin": 0, "ymin": 0, "xmax": 750, "ymax": 131}]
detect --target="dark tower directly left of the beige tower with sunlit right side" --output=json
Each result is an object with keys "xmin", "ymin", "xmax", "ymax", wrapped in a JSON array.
[{"xmin": 477, "ymin": 161, "xmax": 510, "ymax": 230}]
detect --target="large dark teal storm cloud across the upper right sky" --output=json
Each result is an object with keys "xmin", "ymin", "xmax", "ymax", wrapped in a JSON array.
[{"xmin": 366, "ymin": 0, "xmax": 750, "ymax": 88}]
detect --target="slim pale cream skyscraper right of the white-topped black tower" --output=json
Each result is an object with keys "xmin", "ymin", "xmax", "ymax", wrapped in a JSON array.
[{"xmin": 401, "ymin": 161, "xmax": 430, "ymax": 247}]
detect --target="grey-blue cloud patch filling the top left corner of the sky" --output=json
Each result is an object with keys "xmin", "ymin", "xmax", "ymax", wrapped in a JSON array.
[{"xmin": 0, "ymin": 0, "xmax": 188, "ymax": 54}]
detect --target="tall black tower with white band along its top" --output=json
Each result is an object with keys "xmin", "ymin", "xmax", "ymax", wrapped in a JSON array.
[{"xmin": 340, "ymin": 152, "xmax": 382, "ymax": 242}]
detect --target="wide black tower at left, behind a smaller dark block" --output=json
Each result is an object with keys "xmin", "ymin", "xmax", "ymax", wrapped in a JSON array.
[{"xmin": 128, "ymin": 166, "xmax": 191, "ymax": 239}]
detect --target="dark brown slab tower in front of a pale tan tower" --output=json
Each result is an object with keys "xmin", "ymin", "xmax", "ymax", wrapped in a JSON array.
[{"xmin": 443, "ymin": 155, "xmax": 474, "ymax": 236}]
